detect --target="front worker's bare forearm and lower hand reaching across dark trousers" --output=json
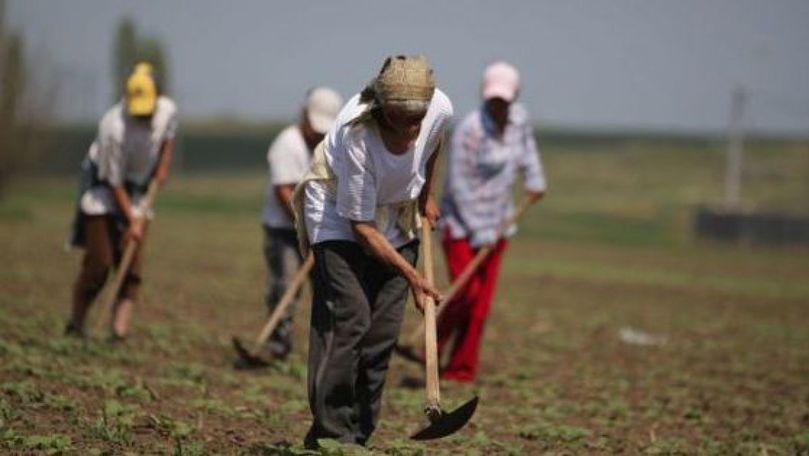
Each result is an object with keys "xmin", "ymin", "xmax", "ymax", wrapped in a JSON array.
[{"xmin": 351, "ymin": 220, "xmax": 441, "ymax": 310}]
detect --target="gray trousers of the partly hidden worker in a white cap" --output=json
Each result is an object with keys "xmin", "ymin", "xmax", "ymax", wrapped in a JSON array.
[{"xmin": 264, "ymin": 226, "xmax": 303, "ymax": 357}]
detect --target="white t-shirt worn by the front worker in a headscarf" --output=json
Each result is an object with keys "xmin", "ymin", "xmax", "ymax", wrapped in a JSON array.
[{"xmin": 304, "ymin": 89, "xmax": 452, "ymax": 248}]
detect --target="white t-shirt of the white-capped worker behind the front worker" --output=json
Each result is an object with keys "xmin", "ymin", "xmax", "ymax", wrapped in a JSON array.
[{"xmin": 261, "ymin": 125, "xmax": 312, "ymax": 229}]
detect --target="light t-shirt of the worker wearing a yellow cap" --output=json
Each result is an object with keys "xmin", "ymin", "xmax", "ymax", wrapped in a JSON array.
[{"xmin": 80, "ymin": 96, "xmax": 177, "ymax": 215}]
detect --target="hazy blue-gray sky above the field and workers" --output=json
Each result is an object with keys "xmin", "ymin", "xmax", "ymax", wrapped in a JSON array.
[{"xmin": 6, "ymin": 0, "xmax": 809, "ymax": 135}]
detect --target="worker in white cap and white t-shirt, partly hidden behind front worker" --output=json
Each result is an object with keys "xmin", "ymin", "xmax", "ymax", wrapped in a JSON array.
[{"xmin": 261, "ymin": 87, "xmax": 343, "ymax": 359}]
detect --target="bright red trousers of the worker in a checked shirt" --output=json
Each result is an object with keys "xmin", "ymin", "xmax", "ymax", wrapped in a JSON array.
[{"xmin": 438, "ymin": 230, "xmax": 508, "ymax": 382}]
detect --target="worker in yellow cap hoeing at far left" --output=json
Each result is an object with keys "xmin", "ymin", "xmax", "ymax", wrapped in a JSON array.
[{"xmin": 65, "ymin": 63, "xmax": 177, "ymax": 340}]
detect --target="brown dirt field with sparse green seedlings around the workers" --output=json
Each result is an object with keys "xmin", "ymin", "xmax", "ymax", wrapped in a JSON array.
[{"xmin": 0, "ymin": 141, "xmax": 809, "ymax": 455}]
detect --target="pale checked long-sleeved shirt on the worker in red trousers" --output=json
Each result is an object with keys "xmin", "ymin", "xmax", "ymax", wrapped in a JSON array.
[{"xmin": 441, "ymin": 103, "xmax": 546, "ymax": 239}]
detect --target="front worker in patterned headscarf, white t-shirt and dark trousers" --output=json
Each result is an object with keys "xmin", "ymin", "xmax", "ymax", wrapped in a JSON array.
[{"xmin": 293, "ymin": 55, "xmax": 452, "ymax": 448}]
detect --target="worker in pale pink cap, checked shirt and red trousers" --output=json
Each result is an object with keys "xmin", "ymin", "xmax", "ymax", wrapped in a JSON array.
[{"xmin": 438, "ymin": 62, "xmax": 546, "ymax": 382}]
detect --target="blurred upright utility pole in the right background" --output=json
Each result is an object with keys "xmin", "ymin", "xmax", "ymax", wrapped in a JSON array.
[{"xmin": 724, "ymin": 86, "xmax": 747, "ymax": 209}]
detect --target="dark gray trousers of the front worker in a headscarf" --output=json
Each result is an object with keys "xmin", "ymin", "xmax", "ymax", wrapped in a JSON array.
[{"xmin": 304, "ymin": 241, "xmax": 418, "ymax": 448}]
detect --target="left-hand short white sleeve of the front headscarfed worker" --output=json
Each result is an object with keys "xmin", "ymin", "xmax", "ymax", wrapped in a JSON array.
[{"xmin": 336, "ymin": 144, "xmax": 377, "ymax": 222}]
